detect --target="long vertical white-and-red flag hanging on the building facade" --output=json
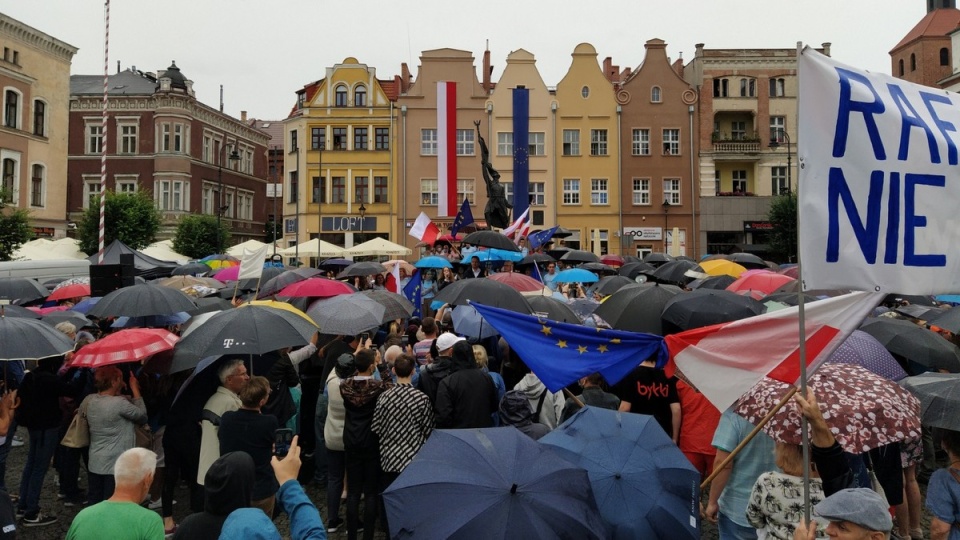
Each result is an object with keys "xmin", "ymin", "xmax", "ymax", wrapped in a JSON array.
[{"xmin": 437, "ymin": 81, "xmax": 457, "ymax": 217}]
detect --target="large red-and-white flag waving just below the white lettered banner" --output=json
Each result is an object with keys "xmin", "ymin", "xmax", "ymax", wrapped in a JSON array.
[{"xmin": 664, "ymin": 292, "xmax": 885, "ymax": 411}]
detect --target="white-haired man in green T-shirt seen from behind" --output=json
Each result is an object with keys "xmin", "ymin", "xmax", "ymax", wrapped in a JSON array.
[{"xmin": 67, "ymin": 448, "xmax": 163, "ymax": 540}]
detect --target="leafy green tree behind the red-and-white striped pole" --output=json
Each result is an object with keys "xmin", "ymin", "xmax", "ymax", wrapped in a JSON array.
[{"xmin": 77, "ymin": 191, "xmax": 161, "ymax": 255}]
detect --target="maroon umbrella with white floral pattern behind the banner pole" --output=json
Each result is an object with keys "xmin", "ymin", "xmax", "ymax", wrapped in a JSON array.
[{"xmin": 734, "ymin": 363, "xmax": 920, "ymax": 454}]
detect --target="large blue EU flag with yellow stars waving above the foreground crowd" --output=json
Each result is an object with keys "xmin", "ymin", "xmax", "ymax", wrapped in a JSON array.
[{"xmin": 470, "ymin": 302, "xmax": 668, "ymax": 392}]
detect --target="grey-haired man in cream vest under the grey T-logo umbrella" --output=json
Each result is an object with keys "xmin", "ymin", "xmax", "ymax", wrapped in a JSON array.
[{"xmin": 197, "ymin": 358, "xmax": 250, "ymax": 486}]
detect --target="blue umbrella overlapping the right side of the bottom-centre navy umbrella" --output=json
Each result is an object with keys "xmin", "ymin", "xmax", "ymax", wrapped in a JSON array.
[{"xmin": 540, "ymin": 407, "xmax": 700, "ymax": 539}]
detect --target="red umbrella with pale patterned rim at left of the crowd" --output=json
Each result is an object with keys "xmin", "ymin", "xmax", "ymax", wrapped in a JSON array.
[{"xmin": 70, "ymin": 328, "xmax": 180, "ymax": 368}]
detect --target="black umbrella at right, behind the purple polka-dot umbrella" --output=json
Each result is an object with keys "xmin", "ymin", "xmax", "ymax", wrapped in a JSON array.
[{"xmin": 860, "ymin": 317, "xmax": 960, "ymax": 373}]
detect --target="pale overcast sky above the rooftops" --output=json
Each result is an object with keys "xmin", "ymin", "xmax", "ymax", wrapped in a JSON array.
[{"xmin": 0, "ymin": 0, "xmax": 926, "ymax": 119}]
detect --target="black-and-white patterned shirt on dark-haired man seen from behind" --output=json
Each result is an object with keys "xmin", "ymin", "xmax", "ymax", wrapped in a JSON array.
[{"xmin": 371, "ymin": 384, "xmax": 433, "ymax": 473}]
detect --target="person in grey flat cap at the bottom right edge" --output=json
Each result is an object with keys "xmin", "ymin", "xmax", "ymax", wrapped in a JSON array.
[{"xmin": 793, "ymin": 488, "xmax": 893, "ymax": 540}]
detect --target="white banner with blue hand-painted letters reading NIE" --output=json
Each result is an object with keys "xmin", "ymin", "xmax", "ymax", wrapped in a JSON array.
[{"xmin": 798, "ymin": 47, "xmax": 960, "ymax": 294}]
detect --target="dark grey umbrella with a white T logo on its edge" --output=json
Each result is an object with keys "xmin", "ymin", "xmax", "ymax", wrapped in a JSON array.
[{"xmin": 177, "ymin": 304, "xmax": 317, "ymax": 358}]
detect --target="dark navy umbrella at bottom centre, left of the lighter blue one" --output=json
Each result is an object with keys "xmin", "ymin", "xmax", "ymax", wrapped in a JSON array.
[{"xmin": 383, "ymin": 427, "xmax": 607, "ymax": 538}]
